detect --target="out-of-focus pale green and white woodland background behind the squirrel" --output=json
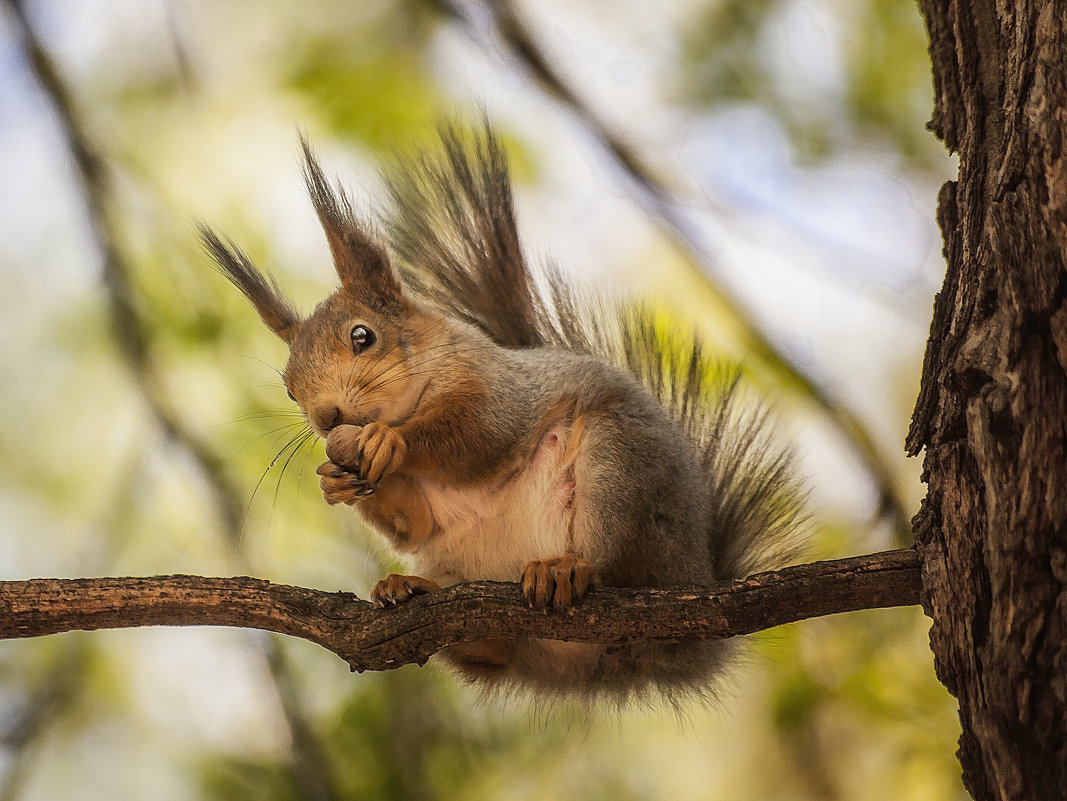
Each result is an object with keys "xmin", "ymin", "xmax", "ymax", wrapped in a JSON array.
[{"xmin": 0, "ymin": 0, "xmax": 966, "ymax": 801}]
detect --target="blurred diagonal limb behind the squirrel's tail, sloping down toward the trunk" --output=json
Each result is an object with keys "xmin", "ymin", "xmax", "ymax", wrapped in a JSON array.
[{"xmin": 431, "ymin": 0, "xmax": 911, "ymax": 543}]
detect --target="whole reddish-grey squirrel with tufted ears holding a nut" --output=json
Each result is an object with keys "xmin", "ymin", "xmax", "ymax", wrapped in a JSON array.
[{"xmin": 201, "ymin": 123, "xmax": 803, "ymax": 699}]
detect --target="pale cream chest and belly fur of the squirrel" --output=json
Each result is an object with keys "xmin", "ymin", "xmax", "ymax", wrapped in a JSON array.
[{"xmin": 414, "ymin": 424, "xmax": 577, "ymax": 586}]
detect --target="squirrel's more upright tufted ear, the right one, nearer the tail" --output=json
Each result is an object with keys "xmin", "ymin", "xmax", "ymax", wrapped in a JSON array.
[{"xmin": 300, "ymin": 137, "xmax": 402, "ymax": 313}]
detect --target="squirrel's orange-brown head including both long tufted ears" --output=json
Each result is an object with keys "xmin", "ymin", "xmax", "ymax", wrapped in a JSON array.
[{"xmin": 200, "ymin": 140, "xmax": 444, "ymax": 436}]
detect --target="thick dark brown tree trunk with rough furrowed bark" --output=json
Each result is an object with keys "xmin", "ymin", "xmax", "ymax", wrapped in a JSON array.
[{"xmin": 908, "ymin": 0, "xmax": 1067, "ymax": 801}]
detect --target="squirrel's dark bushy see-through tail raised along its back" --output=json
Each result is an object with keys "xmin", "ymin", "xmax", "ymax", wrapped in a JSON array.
[{"xmin": 385, "ymin": 124, "xmax": 805, "ymax": 580}]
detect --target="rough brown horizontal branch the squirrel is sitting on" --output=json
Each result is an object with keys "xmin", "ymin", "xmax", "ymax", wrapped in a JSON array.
[{"xmin": 0, "ymin": 550, "xmax": 921, "ymax": 672}]
